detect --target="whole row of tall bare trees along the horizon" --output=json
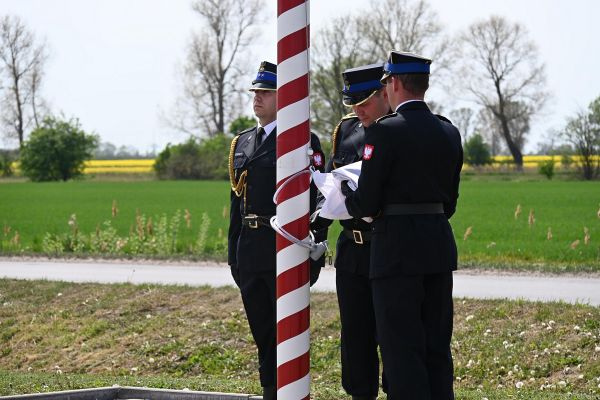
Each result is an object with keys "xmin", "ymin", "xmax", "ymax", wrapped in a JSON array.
[{"xmin": 0, "ymin": 0, "xmax": 600, "ymax": 177}]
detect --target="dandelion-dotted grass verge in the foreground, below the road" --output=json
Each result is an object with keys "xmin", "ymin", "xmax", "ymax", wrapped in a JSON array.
[{"xmin": 0, "ymin": 280, "xmax": 600, "ymax": 400}]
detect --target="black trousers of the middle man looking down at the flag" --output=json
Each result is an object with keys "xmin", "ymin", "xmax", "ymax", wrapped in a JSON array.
[{"xmin": 336, "ymin": 269, "xmax": 379, "ymax": 396}]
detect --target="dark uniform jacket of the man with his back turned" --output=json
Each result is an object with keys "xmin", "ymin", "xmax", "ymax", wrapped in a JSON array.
[{"xmin": 346, "ymin": 101, "xmax": 463, "ymax": 278}]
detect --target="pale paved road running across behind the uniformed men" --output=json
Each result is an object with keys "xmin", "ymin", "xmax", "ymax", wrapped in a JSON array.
[{"xmin": 0, "ymin": 259, "xmax": 600, "ymax": 306}]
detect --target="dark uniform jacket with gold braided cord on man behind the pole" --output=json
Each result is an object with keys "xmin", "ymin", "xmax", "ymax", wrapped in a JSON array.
[{"xmin": 228, "ymin": 127, "xmax": 325, "ymax": 272}]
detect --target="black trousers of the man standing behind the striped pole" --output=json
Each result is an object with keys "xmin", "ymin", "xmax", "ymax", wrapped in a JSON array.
[{"xmin": 240, "ymin": 269, "xmax": 277, "ymax": 387}]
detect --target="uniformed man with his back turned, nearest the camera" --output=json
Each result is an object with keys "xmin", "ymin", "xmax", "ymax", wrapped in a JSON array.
[{"xmin": 342, "ymin": 51, "xmax": 463, "ymax": 400}]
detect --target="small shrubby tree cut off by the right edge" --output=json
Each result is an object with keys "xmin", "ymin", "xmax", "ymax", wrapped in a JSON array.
[{"xmin": 562, "ymin": 97, "xmax": 600, "ymax": 180}]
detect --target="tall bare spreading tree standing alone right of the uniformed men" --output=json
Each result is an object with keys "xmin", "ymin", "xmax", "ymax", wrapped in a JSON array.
[{"xmin": 460, "ymin": 16, "xmax": 547, "ymax": 170}]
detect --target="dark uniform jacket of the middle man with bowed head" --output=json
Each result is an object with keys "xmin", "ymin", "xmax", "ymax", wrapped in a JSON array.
[{"xmin": 325, "ymin": 114, "xmax": 371, "ymax": 276}]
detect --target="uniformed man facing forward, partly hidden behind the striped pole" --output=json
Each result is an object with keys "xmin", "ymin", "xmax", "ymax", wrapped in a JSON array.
[{"xmin": 228, "ymin": 61, "xmax": 327, "ymax": 400}]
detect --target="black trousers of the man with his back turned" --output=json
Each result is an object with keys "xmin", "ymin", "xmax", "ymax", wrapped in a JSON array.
[{"xmin": 371, "ymin": 272, "xmax": 454, "ymax": 400}]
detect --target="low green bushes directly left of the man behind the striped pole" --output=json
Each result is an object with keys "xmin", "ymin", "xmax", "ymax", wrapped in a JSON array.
[{"xmin": 154, "ymin": 134, "xmax": 231, "ymax": 179}]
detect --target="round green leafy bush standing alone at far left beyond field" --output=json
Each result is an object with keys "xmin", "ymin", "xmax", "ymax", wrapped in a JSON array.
[{"xmin": 21, "ymin": 117, "xmax": 99, "ymax": 182}]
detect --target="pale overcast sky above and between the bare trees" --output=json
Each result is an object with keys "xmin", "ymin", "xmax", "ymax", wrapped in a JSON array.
[{"xmin": 0, "ymin": 0, "xmax": 600, "ymax": 152}]
